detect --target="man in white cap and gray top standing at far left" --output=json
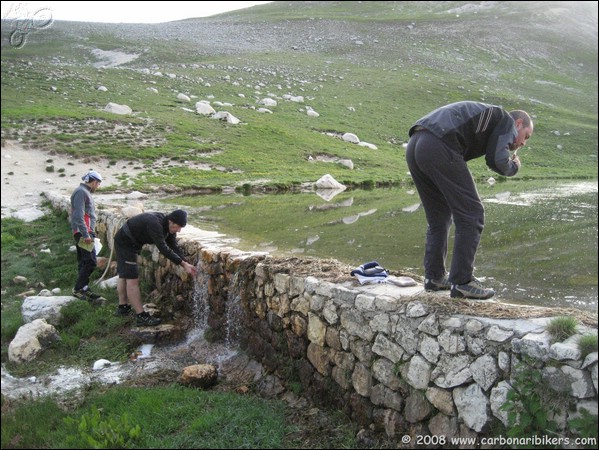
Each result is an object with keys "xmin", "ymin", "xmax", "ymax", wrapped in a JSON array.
[{"xmin": 71, "ymin": 170, "xmax": 104, "ymax": 302}]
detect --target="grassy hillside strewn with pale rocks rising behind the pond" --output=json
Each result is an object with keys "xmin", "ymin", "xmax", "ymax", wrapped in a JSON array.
[{"xmin": 2, "ymin": 2, "xmax": 597, "ymax": 190}]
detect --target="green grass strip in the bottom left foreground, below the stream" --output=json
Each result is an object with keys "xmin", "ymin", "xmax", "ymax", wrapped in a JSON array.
[{"xmin": 2, "ymin": 385, "xmax": 289, "ymax": 448}]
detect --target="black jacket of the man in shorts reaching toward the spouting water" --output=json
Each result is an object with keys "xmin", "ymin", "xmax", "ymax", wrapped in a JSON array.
[{"xmin": 123, "ymin": 212, "xmax": 183, "ymax": 265}]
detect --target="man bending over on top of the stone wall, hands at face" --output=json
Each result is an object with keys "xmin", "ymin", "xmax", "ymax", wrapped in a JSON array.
[{"xmin": 406, "ymin": 101, "xmax": 533, "ymax": 299}]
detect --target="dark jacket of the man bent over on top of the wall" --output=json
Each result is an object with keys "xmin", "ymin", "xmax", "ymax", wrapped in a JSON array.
[{"xmin": 409, "ymin": 102, "xmax": 518, "ymax": 177}]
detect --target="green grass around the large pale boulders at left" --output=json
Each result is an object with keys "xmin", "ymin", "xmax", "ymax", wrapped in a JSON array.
[{"xmin": 2, "ymin": 212, "xmax": 136, "ymax": 376}]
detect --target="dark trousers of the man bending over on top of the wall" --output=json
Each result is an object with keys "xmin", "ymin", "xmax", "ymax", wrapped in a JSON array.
[{"xmin": 406, "ymin": 130, "xmax": 485, "ymax": 284}]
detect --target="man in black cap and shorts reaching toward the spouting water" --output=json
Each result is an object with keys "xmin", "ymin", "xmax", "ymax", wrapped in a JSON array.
[{"xmin": 114, "ymin": 209, "xmax": 198, "ymax": 326}]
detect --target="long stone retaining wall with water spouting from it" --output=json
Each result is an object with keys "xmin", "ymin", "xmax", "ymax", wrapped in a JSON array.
[{"xmin": 48, "ymin": 195, "xmax": 598, "ymax": 438}]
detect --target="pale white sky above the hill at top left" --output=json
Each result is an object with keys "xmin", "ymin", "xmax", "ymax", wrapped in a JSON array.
[{"xmin": 2, "ymin": 1, "xmax": 270, "ymax": 23}]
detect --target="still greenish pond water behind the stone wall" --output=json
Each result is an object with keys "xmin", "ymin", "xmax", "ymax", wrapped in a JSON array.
[{"xmin": 170, "ymin": 180, "xmax": 598, "ymax": 311}]
